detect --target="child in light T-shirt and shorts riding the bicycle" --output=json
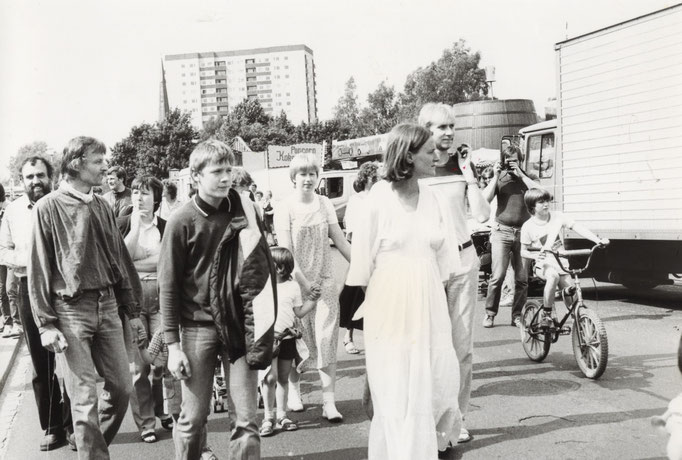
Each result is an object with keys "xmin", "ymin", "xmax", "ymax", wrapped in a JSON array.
[{"xmin": 521, "ymin": 188, "xmax": 609, "ymax": 320}]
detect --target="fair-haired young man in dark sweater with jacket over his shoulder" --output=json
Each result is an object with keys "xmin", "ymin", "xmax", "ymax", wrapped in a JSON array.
[{"xmin": 158, "ymin": 140, "xmax": 275, "ymax": 459}]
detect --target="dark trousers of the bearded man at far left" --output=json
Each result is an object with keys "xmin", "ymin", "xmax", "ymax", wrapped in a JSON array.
[{"xmin": 19, "ymin": 277, "xmax": 73, "ymax": 435}]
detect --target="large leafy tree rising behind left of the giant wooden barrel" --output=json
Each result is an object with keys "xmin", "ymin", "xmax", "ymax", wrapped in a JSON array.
[{"xmin": 401, "ymin": 40, "xmax": 488, "ymax": 117}]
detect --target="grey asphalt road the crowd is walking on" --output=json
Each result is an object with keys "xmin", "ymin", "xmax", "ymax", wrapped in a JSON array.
[{"xmin": 0, "ymin": 250, "xmax": 682, "ymax": 460}]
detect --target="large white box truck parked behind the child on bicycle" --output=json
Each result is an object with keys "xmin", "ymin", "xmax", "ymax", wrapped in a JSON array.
[{"xmin": 521, "ymin": 4, "xmax": 682, "ymax": 288}]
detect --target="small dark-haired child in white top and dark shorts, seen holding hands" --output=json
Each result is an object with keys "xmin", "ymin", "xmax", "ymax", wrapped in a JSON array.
[{"xmin": 260, "ymin": 247, "xmax": 315, "ymax": 436}]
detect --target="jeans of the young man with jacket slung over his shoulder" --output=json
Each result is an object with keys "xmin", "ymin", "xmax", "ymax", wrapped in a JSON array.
[{"xmin": 173, "ymin": 325, "xmax": 260, "ymax": 460}]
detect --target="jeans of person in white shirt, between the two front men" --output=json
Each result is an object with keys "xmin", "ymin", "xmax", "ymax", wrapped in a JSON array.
[{"xmin": 123, "ymin": 278, "xmax": 164, "ymax": 432}]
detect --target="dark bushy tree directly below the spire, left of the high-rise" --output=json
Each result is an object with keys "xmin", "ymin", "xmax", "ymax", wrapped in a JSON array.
[{"xmin": 111, "ymin": 109, "xmax": 198, "ymax": 179}]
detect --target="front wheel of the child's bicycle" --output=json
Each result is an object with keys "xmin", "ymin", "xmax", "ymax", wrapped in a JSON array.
[{"xmin": 573, "ymin": 308, "xmax": 609, "ymax": 379}]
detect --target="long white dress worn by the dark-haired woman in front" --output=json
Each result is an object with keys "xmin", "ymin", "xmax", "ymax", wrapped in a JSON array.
[{"xmin": 346, "ymin": 181, "xmax": 461, "ymax": 460}]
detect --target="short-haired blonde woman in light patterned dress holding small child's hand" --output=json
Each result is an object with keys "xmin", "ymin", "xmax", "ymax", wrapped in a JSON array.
[{"xmin": 275, "ymin": 154, "xmax": 350, "ymax": 422}]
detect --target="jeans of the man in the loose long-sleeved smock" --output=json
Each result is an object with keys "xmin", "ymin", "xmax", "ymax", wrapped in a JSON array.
[{"xmin": 53, "ymin": 287, "xmax": 132, "ymax": 460}]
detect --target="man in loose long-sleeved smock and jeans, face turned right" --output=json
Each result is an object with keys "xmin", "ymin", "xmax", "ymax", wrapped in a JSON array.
[{"xmin": 27, "ymin": 136, "xmax": 143, "ymax": 460}]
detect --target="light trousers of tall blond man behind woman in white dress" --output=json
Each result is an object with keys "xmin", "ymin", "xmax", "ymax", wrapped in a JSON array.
[{"xmin": 446, "ymin": 246, "xmax": 481, "ymax": 416}]
